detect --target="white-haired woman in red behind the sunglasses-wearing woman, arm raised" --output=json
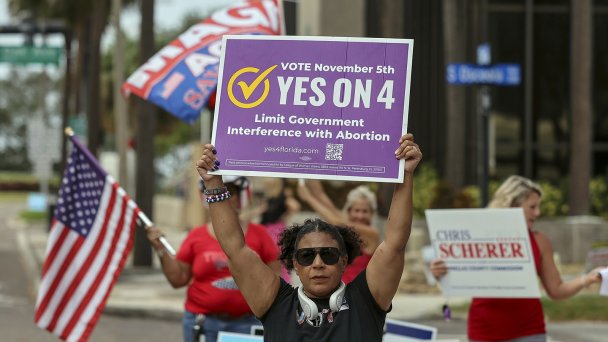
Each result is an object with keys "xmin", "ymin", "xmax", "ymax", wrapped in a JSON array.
[{"xmin": 298, "ymin": 180, "xmax": 380, "ymax": 284}]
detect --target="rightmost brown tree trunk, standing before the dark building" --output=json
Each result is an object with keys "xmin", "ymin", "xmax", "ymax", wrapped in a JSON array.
[{"xmin": 568, "ymin": 0, "xmax": 593, "ymax": 215}]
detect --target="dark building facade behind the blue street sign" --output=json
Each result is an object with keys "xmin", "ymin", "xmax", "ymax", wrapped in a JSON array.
[{"xmin": 286, "ymin": 0, "xmax": 608, "ymax": 200}]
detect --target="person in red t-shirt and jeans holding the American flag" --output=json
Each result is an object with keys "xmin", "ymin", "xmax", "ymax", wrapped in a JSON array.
[{"xmin": 147, "ymin": 177, "xmax": 280, "ymax": 342}]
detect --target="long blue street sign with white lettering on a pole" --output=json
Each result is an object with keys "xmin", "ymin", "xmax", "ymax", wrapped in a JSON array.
[{"xmin": 446, "ymin": 64, "xmax": 521, "ymax": 86}]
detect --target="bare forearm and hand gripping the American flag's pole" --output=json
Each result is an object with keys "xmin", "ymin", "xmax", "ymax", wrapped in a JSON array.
[{"xmin": 146, "ymin": 227, "xmax": 192, "ymax": 289}]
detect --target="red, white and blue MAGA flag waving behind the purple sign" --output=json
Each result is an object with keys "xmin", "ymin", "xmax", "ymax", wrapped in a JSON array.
[{"xmin": 122, "ymin": 0, "xmax": 284, "ymax": 123}]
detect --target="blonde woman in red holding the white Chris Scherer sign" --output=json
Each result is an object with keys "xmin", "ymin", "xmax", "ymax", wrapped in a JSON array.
[{"xmin": 431, "ymin": 176, "xmax": 601, "ymax": 342}]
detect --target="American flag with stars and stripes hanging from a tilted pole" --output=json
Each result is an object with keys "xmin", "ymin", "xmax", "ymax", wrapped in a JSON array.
[{"xmin": 34, "ymin": 137, "xmax": 139, "ymax": 341}]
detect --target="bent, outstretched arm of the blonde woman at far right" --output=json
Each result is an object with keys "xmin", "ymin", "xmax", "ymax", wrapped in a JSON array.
[{"xmin": 534, "ymin": 232, "xmax": 602, "ymax": 299}]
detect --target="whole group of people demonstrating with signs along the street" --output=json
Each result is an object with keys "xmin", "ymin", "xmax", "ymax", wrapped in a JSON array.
[{"xmin": 148, "ymin": 134, "xmax": 601, "ymax": 342}]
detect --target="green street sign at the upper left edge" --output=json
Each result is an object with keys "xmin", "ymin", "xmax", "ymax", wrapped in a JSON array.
[{"xmin": 0, "ymin": 46, "xmax": 62, "ymax": 65}]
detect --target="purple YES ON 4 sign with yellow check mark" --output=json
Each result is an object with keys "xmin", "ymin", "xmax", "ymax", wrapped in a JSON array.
[{"xmin": 212, "ymin": 35, "xmax": 413, "ymax": 182}]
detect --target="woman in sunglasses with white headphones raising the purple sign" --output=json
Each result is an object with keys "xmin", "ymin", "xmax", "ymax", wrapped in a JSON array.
[{"xmin": 197, "ymin": 134, "xmax": 422, "ymax": 341}]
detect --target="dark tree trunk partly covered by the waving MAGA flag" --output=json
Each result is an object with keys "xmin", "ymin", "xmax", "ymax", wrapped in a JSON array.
[{"xmin": 133, "ymin": 0, "xmax": 157, "ymax": 267}]
